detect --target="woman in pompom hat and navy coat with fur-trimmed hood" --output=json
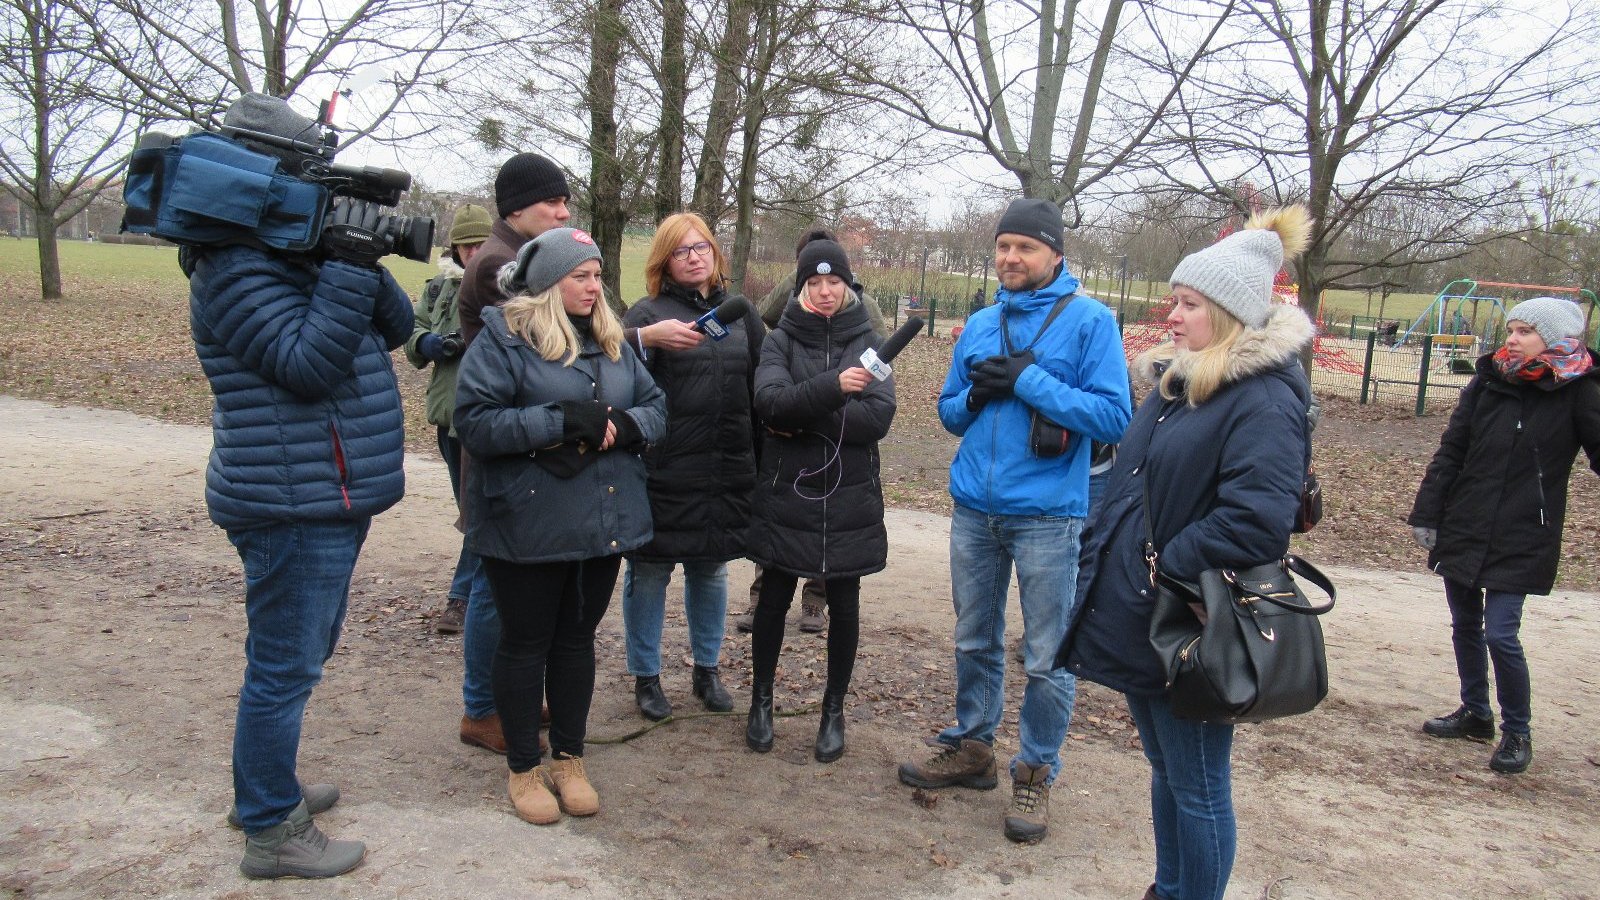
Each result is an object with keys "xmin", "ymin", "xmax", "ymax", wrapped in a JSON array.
[{"xmin": 1056, "ymin": 207, "xmax": 1314, "ymax": 900}]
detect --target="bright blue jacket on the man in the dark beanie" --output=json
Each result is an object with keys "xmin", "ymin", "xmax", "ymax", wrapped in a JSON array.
[{"xmin": 939, "ymin": 264, "xmax": 1133, "ymax": 517}]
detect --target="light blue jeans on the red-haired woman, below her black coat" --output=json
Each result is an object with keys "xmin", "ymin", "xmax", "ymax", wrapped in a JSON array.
[{"xmin": 622, "ymin": 559, "xmax": 728, "ymax": 677}]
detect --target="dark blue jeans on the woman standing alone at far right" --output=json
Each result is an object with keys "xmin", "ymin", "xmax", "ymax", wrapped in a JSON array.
[{"xmin": 1445, "ymin": 578, "xmax": 1533, "ymax": 735}]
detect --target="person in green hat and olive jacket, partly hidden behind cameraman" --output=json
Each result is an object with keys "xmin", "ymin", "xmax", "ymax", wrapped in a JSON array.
[{"xmin": 405, "ymin": 203, "xmax": 494, "ymax": 634}]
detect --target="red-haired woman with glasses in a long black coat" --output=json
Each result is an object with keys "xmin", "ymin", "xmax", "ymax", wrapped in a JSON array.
[{"xmin": 622, "ymin": 213, "xmax": 766, "ymax": 719}]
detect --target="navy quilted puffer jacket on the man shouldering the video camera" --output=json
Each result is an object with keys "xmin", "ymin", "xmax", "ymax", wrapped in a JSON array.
[{"xmin": 189, "ymin": 245, "xmax": 413, "ymax": 530}]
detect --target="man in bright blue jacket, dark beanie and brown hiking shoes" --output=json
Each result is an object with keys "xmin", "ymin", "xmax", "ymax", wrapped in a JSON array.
[{"xmin": 899, "ymin": 200, "xmax": 1133, "ymax": 844}]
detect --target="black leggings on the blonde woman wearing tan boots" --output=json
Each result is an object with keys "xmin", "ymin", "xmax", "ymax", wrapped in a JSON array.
[{"xmin": 483, "ymin": 556, "xmax": 622, "ymax": 772}]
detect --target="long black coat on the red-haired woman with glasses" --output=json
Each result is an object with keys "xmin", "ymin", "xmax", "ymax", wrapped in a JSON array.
[{"xmin": 624, "ymin": 282, "xmax": 766, "ymax": 562}]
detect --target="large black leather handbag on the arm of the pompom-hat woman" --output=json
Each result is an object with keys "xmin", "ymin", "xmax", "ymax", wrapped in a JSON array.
[{"xmin": 1144, "ymin": 477, "xmax": 1336, "ymax": 724}]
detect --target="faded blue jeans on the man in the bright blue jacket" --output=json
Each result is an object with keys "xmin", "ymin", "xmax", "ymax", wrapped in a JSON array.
[{"xmin": 939, "ymin": 504, "xmax": 1083, "ymax": 783}]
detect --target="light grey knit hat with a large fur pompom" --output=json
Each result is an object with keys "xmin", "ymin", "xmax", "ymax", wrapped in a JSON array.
[{"xmin": 1171, "ymin": 205, "xmax": 1310, "ymax": 328}]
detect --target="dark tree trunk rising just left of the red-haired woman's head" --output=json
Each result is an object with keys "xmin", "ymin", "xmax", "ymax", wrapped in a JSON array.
[{"xmin": 586, "ymin": 0, "xmax": 627, "ymax": 315}]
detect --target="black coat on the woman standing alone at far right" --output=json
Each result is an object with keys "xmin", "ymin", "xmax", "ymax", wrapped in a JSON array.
[{"xmin": 1406, "ymin": 351, "xmax": 1600, "ymax": 594}]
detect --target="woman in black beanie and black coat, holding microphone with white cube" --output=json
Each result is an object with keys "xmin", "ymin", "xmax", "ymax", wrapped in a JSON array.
[{"xmin": 744, "ymin": 240, "xmax": 894, "ymax": 762}]
